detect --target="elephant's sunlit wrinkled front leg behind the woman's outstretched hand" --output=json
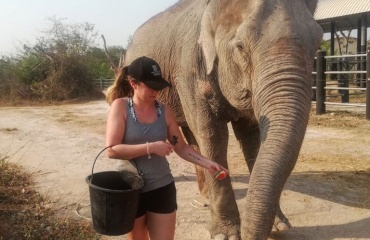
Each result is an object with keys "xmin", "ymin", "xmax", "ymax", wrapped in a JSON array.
[{"xmin": 192, "ymin": 116, "xmax": 240, "ymax": 239}]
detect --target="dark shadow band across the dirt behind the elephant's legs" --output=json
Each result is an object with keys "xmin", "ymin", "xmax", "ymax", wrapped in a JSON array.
[{"xmin": 175, "ymin": 171, "xmax": 370, "ymax": 209}]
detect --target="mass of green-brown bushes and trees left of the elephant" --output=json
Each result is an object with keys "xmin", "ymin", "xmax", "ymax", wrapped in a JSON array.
[{"xmin": 0, "ymin": 18, "xmax": 125, "ymax": 100}]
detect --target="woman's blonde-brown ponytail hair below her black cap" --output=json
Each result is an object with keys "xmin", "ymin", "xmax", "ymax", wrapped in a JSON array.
[{"xmin": 106, "ymin": 67, "xmax": 134, "ymax": 105}]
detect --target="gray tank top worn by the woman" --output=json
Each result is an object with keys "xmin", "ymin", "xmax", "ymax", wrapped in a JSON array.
[{"xmin": 122, "ymin": 98, "xmax": 174, "ymax": 192}]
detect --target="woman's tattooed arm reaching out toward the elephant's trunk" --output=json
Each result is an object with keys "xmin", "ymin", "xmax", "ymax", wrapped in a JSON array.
[{"xmin": 166, "ymin": 105, "xmax": 229, "ymax": 174}]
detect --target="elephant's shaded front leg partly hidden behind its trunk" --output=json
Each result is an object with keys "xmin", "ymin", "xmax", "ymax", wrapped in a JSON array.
[{"xmin": 231, "ymin": 118, "xmax": 292, "ymax": 231}]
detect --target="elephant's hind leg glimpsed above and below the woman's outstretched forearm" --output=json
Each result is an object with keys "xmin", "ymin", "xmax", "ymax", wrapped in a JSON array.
[{"xmin": 181, "ymin": 127, "xmax": 209, "ymax": 199}]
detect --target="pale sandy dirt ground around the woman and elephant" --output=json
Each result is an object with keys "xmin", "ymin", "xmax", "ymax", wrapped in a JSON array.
[{"xmin": 0, "ymin": 101, "xmax": 370, "ymax": 240}]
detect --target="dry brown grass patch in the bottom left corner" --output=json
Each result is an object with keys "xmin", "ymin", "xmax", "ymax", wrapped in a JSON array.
[{"xmin": 0, "ymin": 157, "xmax": 100, "ymax": 240}]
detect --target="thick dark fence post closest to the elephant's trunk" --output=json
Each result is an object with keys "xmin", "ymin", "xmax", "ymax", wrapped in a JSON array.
[{"xmin": 316, "ymin": 50, "xmax": 326, "ymax": 115}]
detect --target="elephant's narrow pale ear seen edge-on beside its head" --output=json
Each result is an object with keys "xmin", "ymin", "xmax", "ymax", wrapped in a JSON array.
[{"xmin": 198, "ymin": 8, "xmax": 217, "ymax": 74}]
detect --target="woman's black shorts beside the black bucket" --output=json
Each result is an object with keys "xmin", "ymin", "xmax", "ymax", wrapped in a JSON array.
[{"xmin": 136, "ymin": 182, "xmax": 177, "ymax": 218}]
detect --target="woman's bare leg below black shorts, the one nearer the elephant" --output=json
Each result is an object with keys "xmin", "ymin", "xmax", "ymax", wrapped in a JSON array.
[{"xmin": 146, "ymin": 211, "xmax": 176, "ymax": 240}]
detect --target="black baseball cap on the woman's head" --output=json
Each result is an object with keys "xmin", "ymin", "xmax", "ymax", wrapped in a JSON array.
[{"xmin": 128, "ymin": 56, "xmax": 171, "ymax": 91}]
